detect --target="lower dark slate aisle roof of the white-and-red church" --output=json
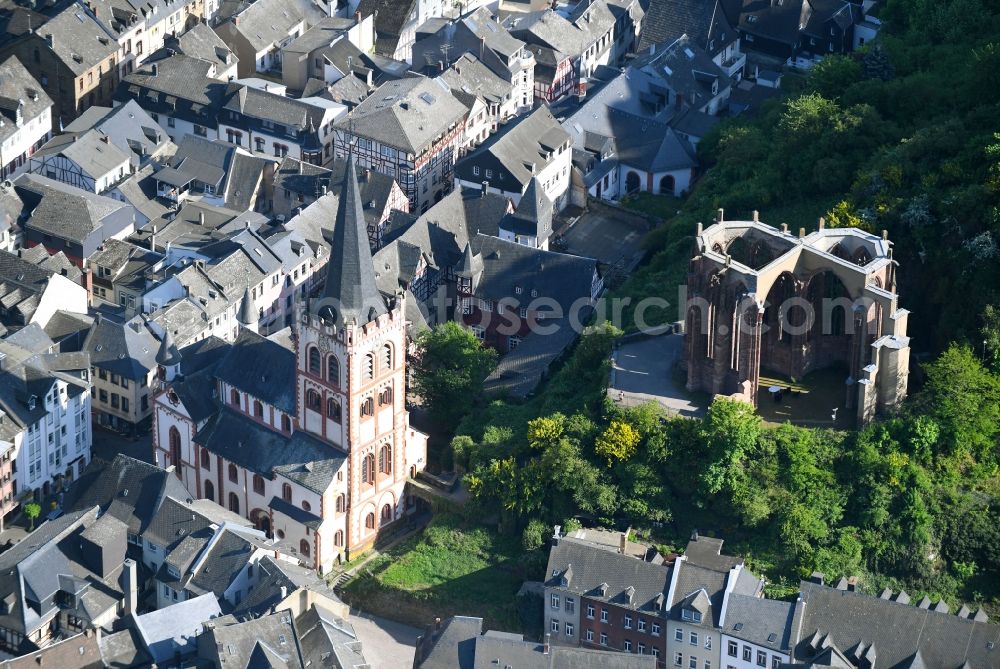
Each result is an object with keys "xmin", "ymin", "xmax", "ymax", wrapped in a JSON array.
[{"xmin": 195, "ymin": 407, "xmax": 346, "ymax": 494}]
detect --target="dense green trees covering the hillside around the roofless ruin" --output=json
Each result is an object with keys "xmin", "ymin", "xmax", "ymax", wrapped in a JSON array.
[{"xmin": 453, "ymin": 0, "xmax": 1000, "ymax": 607}]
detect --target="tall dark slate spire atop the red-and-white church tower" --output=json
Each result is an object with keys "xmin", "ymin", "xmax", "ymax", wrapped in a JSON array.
[{"xmin": 320, "ymin": 154, "xmax": 386, "ymax": 327}]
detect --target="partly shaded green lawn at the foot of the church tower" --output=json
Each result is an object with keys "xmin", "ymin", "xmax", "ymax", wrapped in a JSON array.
[{"xmin": 344, "ymin": 514, "xmax": 542, "ymax": 631}]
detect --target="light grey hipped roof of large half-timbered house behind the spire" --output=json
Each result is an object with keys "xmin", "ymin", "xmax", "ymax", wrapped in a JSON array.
[{"xmin": 335, "ymin": 77, "xmax": 468, "ymax": 155}]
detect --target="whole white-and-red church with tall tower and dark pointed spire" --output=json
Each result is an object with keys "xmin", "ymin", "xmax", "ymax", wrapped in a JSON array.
[{"xmin": 153, "ymin": 163, "xmax": 427, "ymax": 571}]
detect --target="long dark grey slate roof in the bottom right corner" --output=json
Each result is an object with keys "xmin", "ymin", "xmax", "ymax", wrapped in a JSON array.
[{"xmin": 792, "ymin": 581, "xmax": 1000, "ymax": 669}]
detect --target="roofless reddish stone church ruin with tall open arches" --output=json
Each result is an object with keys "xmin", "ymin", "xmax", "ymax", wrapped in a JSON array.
[{"xmin": 684, "ymin": 209, "xmax": 910, "ymax": 424}]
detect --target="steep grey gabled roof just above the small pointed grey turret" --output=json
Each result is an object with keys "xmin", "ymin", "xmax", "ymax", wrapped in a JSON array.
[{"xmin": 455, "ymin": 105, "xmax": 570, "ymax": 193}]
